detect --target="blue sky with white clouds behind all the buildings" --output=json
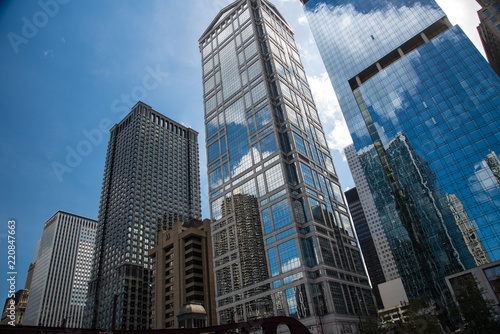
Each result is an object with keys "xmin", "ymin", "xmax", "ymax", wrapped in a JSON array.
[{"xmin": 0, "ymin": 0, "xmax": 480, "ymax": 305}]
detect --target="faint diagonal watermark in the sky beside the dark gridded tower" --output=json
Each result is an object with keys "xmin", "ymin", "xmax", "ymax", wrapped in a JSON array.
[{"xmin": 51, "ymin": 65, "xmax": 168, "ymax": 182}]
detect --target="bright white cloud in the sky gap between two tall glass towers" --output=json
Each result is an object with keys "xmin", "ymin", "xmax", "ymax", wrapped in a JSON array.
[{"xmin": 307, "ymin": 72, "xmax": 352, "ymax": 155}]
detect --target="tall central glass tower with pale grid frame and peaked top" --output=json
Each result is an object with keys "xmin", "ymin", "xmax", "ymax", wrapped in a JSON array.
[{"xmin": 199, "ymin": 0, "xmax": 373, "ymax": 333}]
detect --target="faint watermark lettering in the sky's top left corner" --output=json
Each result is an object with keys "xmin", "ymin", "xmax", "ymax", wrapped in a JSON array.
[{"xmin": 7, "ymin": 0, "xmax": 71, "ymax": 54}]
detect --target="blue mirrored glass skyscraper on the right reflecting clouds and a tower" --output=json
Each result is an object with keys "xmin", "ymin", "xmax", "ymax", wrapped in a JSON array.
[{"xmin": 302, "ymin": 0, "xmax": 500, "ymax": 318}]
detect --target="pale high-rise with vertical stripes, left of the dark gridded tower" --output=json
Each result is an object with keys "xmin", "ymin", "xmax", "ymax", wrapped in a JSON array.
[{"xmin": 23, "ymin": 211, "xmax": 97, "ymax": 328}]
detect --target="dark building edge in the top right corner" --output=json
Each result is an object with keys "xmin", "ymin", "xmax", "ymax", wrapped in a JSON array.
[{"xmin": 477, "ymin": 0, "xmax": 500, "ymax": 75}]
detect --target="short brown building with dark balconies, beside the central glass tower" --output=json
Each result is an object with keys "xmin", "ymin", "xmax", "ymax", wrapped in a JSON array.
[{"xmin": 149, "ymin": 219, "xmax": 217, "ymax": 329}]
